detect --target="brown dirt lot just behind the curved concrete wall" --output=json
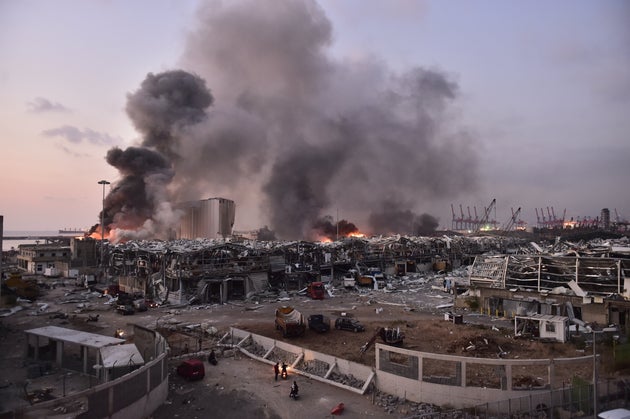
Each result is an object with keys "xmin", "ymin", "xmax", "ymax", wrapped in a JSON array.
[{"xmin": 234, "ymin": 303, "xmax": 612, "ymax": 385}]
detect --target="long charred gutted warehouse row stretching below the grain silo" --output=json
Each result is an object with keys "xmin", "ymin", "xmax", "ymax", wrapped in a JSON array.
[{"xmin": 99, "ymin": 236, "xmax": 520, "ymax": 303}]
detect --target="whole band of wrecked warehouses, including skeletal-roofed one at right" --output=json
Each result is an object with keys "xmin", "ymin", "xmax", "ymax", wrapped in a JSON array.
[{"xmin": 106, "ymin": 236, "xmax": 630, "ymax": 341}]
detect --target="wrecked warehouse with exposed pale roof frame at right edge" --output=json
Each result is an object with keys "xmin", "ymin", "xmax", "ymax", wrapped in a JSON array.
[{"xmin": 459, "ymin": 244, "xmax": 630, "ymax": 333}]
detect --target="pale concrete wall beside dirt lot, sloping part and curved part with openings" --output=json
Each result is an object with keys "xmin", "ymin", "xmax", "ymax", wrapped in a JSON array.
[{"xmin": 217, "ymin": 329, "xmax": 593, "ymax": 409}]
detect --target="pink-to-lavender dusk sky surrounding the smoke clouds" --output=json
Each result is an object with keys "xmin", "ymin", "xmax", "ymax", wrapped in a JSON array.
[{"xmin": 0, "ymin": 0, "xmax": 630, "ymax": 231}]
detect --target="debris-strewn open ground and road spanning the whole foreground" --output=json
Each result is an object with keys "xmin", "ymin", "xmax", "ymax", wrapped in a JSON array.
[{"xmin": 0, "ymin": 284, "xmax": 630, "ymax": 418}]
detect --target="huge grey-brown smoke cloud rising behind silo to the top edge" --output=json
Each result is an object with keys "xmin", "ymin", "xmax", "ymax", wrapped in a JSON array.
[{"xmin": 99, "ymin": 0, "xmax": 477, "ymax": 239}]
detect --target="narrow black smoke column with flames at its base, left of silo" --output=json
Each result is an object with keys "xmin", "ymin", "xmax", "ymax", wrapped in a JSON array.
[{"xmin": 92, "ymin": 70, "xmax": 212, "ymax": 241}]
